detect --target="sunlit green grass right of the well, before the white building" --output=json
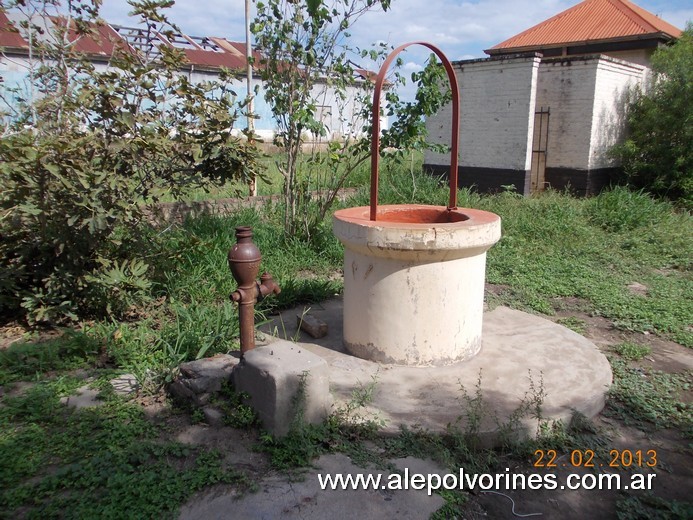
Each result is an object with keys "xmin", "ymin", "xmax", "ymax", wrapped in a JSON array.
[{"xmin": 482, "ymin": 189, "xmax": 693, "ymax": 347}]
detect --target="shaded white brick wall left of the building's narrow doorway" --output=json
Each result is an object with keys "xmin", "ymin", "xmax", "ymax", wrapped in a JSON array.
[{"xmin": 424, "ymin": 57, "xmax": 540, "ymax": 170}]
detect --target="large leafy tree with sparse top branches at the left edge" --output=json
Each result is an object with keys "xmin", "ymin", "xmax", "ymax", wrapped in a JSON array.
[{"xmin": 0, "ymin": 0, "xmax": 255, "ymax": 322}]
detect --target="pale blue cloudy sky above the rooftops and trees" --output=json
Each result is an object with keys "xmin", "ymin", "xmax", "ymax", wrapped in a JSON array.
[{"xmin": 101, "ymin": 0, "xmax": 693, "ymax": 74}]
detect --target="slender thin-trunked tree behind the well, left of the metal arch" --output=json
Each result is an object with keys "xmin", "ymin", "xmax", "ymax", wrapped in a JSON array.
[{"xmin": 252, "ymin": 0, "xmax": 447, "ymax": 238}]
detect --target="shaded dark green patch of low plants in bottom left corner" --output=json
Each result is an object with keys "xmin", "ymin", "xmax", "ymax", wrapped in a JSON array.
[{"xmin": 0, "ymin": 378, "xmax": 248, "ymax": 519}]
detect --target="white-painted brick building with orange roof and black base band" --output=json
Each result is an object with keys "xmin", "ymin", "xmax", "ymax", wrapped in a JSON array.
[{"xmin": 424, "ymin": 0, "xmax": 681, "ymax": 195}]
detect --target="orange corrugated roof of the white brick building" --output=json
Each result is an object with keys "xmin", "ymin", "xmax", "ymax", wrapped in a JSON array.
[{"xmin": 485, "ymin": 0, "xmax": 681, "ymax": 54}]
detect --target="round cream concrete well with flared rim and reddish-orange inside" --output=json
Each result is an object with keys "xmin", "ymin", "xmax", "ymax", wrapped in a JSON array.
[{"xmin": 333, "ymin": 204, "xmax": 501, "ymax": 366}]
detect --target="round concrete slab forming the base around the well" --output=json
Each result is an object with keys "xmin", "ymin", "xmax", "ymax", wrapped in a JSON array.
[{"xmin": 260, "ymin": 299, "xmax": 612, "ymax": 444}]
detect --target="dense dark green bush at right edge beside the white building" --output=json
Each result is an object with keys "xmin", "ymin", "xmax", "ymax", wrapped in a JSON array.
[{"xmin": 614, "ymin": 23, "xmax": 693, "ymax": 208}]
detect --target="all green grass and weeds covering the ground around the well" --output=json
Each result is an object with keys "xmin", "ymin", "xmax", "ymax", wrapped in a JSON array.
[{"xmin": 0, "ymin": 161, "xmax": 693, "ymax": 518}]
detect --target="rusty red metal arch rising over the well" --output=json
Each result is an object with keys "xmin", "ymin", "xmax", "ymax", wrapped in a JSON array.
[{"xmin": 370, "ymin": 42, "xmax": 460, "ymax": 220}]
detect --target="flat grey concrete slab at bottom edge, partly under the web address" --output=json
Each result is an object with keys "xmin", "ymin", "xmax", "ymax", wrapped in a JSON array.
[{"xmin": 179, "ymin": 454, "xmax": 444, "ymax": 520}]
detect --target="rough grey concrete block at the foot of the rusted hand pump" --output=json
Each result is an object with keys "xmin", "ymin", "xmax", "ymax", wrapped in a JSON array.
[{"xmin": 233, "ymin": 340, "xmax": 332, "ymax": 437}]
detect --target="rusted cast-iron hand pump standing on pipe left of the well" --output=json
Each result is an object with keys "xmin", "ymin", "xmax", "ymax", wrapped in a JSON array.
[{"xmin": 228, "ymin": 226, "xmax": 281, "ymax": 357}]
